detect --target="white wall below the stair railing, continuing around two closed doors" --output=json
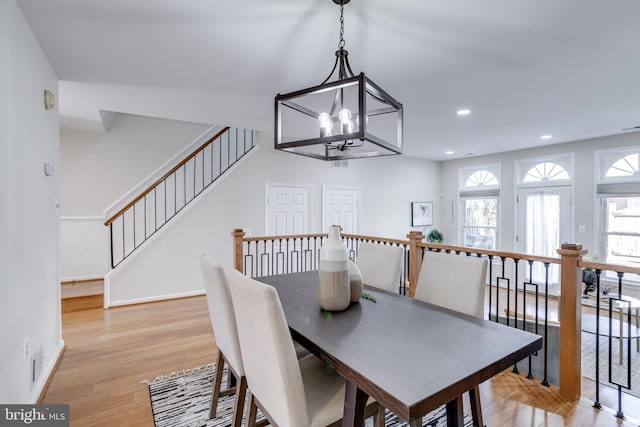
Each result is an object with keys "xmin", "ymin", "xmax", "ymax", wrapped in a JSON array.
[{"xmin": 105, "ymin": 133, "xmax": 439, "ymax": 304}]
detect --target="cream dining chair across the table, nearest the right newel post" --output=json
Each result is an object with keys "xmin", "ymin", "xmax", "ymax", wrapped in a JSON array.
[{"xmin": 414, "ymin": 251, "xmax": 487, "ymax": 426}]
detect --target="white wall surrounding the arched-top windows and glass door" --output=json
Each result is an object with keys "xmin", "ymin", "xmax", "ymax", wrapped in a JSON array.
[{"xmin": 440, "ymin": 132, "xmax": 640, "ymax": 252}]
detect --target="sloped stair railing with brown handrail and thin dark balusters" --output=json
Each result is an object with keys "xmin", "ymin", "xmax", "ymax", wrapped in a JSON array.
[{"xmin": 104, "ymin": 127, "xmax": 255, "ymax": 268}]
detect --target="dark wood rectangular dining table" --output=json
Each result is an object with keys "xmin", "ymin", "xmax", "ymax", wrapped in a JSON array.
[{"xmin": 257, "ymin": 271, "xmax": 542, "ymax": 427}]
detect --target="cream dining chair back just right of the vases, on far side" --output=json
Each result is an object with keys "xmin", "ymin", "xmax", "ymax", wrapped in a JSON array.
[{"xmin": 356, "ymin": 242, "xmax": 402, "ymax": 294}]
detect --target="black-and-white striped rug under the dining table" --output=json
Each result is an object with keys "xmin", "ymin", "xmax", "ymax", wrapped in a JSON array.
[{"xmin": 142, "ymin": 364, "xmax": 473, "ymax": 427}]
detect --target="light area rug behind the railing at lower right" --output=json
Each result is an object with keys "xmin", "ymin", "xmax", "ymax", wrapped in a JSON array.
[{"xmin": 582, "ymin": 332, "xmax": 640, "ymax": 397}]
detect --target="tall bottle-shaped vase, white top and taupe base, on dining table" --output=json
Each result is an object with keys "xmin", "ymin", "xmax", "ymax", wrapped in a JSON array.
[{"xmin": 318, "ymin": 225, "xmax": 351, "ymax": 311}]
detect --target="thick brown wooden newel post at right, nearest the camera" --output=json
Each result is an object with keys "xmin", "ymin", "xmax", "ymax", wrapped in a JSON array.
[{"xmin": 557, "ymin": 243, "xmax": 587, "ymax": 400}]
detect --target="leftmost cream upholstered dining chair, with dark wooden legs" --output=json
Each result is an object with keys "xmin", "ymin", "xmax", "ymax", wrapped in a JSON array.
[{"xmin": 200, "ymin": 254, "xmax": 247, "ymax": 427}]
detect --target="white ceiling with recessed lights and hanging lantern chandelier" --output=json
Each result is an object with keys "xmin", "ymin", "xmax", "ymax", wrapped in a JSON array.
[{"xmin": 16, "ymin": 0, "xmax": 640, "ymax": 160}]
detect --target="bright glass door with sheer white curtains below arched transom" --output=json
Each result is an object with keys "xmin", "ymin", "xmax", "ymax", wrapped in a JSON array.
[{"xmin": 516, "ymin": 186, "xmax": 573, "ymax": 283}]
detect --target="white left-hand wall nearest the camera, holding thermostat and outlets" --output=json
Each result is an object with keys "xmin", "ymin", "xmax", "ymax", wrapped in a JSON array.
[{"xmin": 0, "ymin": 0, "xmax": 64, "ymax": 403}]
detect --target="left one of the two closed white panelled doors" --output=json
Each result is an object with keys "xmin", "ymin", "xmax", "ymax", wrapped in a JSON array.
[{"xmin": 267, "ymin": 185, "xmax": 309, "ymax": 236}]
